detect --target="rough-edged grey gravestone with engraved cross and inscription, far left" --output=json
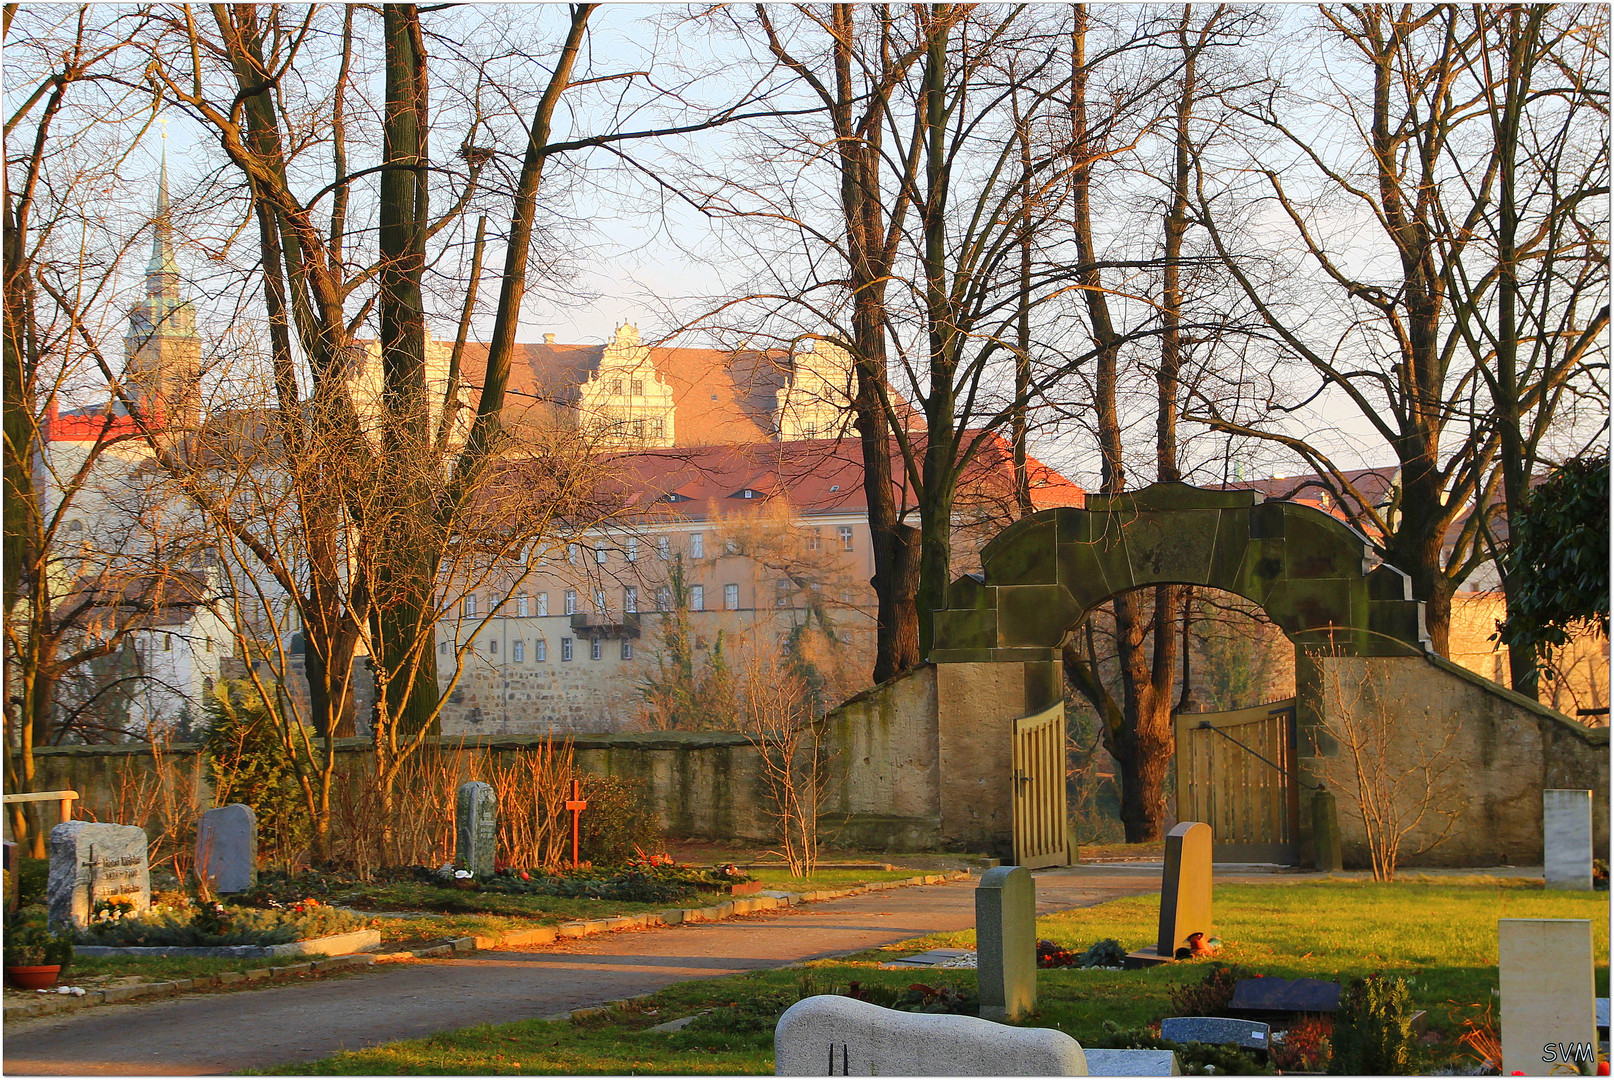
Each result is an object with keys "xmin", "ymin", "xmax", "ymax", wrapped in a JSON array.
[{"xmin": 45, "ymin": 822, "xmax": 152, "ymax": 930}]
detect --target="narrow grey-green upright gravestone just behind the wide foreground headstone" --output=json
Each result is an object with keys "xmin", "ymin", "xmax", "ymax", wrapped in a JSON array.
[{"xmin": 975, "ymin": 867, "xmax": 1036, "ymax": 1020}]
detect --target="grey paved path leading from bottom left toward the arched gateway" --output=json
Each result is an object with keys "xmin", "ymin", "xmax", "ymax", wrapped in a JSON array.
[{"xmin": 5, "ymin": 864, "xmax": 1304, "ymax": 1075}]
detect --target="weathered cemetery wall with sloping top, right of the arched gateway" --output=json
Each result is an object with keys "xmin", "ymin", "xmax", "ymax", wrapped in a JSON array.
[{"xmin": 1296, "ymin": 657, "xmax": 1609, "ymax": 869}]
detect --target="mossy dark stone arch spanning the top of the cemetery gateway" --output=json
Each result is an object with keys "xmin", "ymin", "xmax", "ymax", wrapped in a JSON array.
[{"xmin": 930, "ymin": 483, "xmax": 1428, "ymax": 663}]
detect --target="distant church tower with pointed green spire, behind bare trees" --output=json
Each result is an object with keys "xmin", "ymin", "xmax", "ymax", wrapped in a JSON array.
[{"xmin": 123, "ymin": 152, "xmax": 202, "ymax": 431}]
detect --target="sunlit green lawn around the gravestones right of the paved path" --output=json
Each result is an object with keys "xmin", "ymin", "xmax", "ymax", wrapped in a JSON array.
[{"xmin": 273, "ymin": 877, "xmax": 1609, "ymax": 1075}]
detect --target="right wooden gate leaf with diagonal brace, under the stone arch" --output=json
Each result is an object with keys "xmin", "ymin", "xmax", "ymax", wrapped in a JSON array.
[{"xmin": 1175, "ymin": 697, "xmax": 1301, "ymax": 865}]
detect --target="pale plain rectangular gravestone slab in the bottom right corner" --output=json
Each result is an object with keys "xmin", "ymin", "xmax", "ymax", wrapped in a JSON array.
[{"xmin": 1496, "ymin": 919, "xmax": 1598, "ymax": 1077}]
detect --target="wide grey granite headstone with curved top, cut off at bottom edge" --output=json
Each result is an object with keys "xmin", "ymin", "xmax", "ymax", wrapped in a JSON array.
[{"xmin": 773, "ymin": 987, "xmax": 1088, "ymax": 1077}]
